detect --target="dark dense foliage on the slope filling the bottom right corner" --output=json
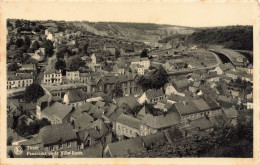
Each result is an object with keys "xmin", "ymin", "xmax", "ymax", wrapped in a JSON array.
[{"xmin": 128, "ymin": 110, "xmax": 253, "ymax": 158}]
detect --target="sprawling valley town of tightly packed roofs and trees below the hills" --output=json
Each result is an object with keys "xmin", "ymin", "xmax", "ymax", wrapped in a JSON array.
[{"xmin": 6, "ymin": 19, "xmax": 253, "ymax": 158}]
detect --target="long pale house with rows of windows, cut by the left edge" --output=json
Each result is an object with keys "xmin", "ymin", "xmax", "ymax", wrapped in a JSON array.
[{"xmin": 7, "ymin": 72, "xmax": 34, "ymax": 89}]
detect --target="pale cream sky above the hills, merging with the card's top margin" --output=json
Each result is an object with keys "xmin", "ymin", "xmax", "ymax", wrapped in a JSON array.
[{"xmin": 2, "ymin": 0, "xmax": 258, "ymax": 27}]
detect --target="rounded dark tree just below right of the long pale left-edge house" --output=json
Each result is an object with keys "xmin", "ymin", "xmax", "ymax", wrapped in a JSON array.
[{"xmin": 24, "ymin": 83, "xmax": 44, "ymax": 103}]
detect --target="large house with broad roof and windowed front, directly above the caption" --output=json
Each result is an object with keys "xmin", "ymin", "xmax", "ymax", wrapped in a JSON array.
[{"xmin": 39, "ymin": 123, "xmax": 79, "ymax": 157}]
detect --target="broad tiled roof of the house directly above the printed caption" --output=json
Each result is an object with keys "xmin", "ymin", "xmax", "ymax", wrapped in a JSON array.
[{"xmin": 40, "ymin": 123, "xmax": 77, "ymax": 146}]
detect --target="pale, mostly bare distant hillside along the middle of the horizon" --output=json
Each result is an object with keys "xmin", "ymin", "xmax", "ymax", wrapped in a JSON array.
[{"xmin": 69, "ymin": 21, "xmax": 195, "ymax": 42}]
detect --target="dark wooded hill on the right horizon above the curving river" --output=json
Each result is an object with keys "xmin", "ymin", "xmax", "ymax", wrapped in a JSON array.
[{"xmin": 189, "ymin": 26, "xmax": 253, "ymax": 50}]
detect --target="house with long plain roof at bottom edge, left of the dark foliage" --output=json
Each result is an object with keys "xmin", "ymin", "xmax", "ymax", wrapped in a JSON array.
[{"xmin": 104, "ymin": 137, "xmax": 147, "ymax": 157}]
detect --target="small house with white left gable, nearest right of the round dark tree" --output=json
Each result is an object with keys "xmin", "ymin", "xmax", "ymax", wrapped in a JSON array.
[{"xmin": 63, "ymin": 89, "xmax": 88, "ymax": 107}]
